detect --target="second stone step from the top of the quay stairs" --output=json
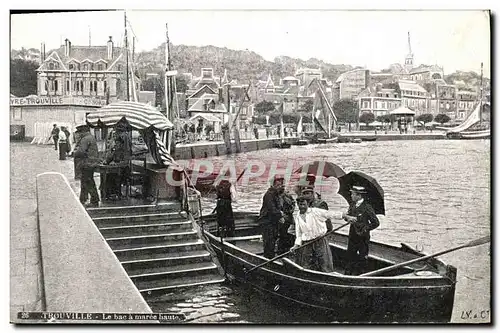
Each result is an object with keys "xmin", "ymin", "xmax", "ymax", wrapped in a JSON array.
[{"xmin": 93, "ymin": 212, "xmax": 188, "ymax": 228}]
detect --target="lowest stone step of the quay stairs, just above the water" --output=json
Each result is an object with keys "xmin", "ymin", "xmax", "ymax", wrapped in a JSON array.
[{"xmin": 136, "ymin": 274, "xmax": 224, "ymax": 298}]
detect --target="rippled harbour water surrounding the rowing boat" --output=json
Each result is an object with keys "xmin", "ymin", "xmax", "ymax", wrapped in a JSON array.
[{"xmin": 155, "ymin": 140, "xmax": 490, "ymax": 323}]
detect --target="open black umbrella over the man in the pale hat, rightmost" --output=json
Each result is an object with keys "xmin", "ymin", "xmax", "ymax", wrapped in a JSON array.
[{"xmin": 338, "ymin": 171, "xmax": 385, "ymax": 215}]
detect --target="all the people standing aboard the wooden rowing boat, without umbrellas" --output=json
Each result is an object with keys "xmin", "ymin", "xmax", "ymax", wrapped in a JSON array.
[{"xmin": 216, "ymin": 172, "xmax": 380, "ymax": 275}]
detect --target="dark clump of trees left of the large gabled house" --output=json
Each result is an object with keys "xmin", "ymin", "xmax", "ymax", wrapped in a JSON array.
[{"xmin": 10, "ymin": 59, "xmax": 39, "ymax": 97}]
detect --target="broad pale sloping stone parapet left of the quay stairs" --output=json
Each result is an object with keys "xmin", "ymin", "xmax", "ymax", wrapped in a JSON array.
[{"xmin": 36, "ymin": 172, "xmax": 152, "ymax": 316}]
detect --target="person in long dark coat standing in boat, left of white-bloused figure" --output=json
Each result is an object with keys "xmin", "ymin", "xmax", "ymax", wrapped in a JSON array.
[{"xmin": 259, "ymin": 176, "xmax": 285, "ymax": 259}]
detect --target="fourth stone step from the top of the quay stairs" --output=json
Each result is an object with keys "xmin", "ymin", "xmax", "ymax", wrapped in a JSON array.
[{"xmin": 106, "ymin": 230, "xmax": 198, "ymax": 250}]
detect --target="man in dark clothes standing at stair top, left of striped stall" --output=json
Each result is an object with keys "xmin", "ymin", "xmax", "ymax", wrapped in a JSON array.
[{"xmin": 75, "ymin": 125, "xmax": 99, "ymax": 207}]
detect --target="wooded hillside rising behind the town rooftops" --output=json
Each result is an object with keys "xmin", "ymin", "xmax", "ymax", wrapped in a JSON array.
[{"xmin": 11, "ymin": 43, "xmax": 490, "ymax": 91}]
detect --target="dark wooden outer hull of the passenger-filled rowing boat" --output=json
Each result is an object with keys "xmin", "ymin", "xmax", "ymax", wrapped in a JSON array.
[{"xmin": 203, "ymin": 230, "xmax": 456, "ymax": 323}]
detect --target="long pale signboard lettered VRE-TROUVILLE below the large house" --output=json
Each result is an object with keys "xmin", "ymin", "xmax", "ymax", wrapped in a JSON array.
[{"xmin": 10, "ymin": 96, "xmax": 106, "ymax": 107}]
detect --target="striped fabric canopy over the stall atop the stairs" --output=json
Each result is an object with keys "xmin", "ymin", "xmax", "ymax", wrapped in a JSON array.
[{"xmin": 87, "ymin": 102, "xmax": 175, "ymax": 165}]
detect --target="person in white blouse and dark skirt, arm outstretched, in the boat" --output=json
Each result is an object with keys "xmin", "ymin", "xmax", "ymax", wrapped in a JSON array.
[{"xmin": 290, "ymin": 196, "xmax": 351, "ymax": 273}]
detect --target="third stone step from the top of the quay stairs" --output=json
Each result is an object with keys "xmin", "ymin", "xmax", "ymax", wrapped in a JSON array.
[{"xmin": 99, "ymin": 221, "xmax": 193, "ymax": 238}]
